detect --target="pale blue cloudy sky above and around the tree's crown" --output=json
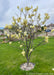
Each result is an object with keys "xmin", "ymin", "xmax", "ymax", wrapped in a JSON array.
[{"xmin": 0, "ymin": 0, "xmax": 54, "ymax": 27}]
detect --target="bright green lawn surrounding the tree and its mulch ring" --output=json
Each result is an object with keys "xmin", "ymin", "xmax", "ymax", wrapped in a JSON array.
[{"xmin": 0, "ymin": 37, "xmax": 54, "ymax": 75}]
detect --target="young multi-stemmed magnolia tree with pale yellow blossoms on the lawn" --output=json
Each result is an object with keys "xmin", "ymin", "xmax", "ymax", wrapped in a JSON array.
[{"xmin": 6, "ymin": 6, "xmax": 49, "ymax": 69}]
